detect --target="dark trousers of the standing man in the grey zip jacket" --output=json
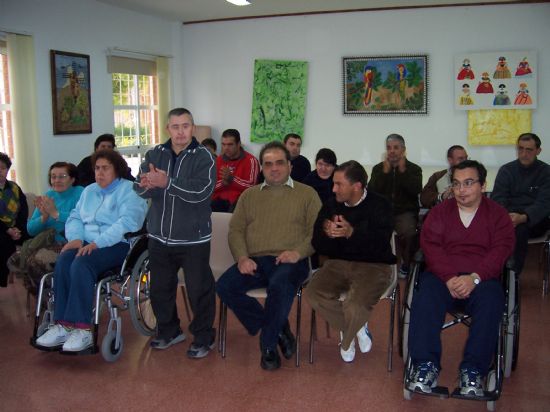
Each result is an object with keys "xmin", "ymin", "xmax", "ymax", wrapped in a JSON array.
[{"xmin": 149, "ymin": 239, "xmax": 216, "ymax": 345}]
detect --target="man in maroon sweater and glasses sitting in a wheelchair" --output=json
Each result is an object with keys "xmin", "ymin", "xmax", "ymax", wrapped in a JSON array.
[{"xmin": 408, "ymin": 160, "xmax": 515, "ymax": 396}]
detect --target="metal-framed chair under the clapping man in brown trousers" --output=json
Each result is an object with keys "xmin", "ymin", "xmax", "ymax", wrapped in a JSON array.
[{"xmin": 309, "ymin": 232, "xmax": 401, "ymax": 372}]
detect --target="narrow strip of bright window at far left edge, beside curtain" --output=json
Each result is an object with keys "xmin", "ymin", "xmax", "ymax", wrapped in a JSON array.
[{"xmin": 0, "ymin": 40, "xmax": 15, "ymax": 180}]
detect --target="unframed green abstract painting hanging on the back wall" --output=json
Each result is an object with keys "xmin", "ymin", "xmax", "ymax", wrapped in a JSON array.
[{"xmin": 250, "ymin": 60, "xmax": 307, "ymax": 143}]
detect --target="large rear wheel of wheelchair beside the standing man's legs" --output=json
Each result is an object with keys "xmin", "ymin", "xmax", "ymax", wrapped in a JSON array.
[{"xmin": 130, "ymin": 250, "xmax": 157, "ymax": 336}]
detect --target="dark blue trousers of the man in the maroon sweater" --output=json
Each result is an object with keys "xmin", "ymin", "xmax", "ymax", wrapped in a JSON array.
[{"xmin": 409, "ymin": 272, "xmax": 504, "ymax": 376}]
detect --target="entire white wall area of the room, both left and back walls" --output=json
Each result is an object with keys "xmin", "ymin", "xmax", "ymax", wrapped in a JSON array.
[{"xmin": 0, "ymin": 0, "xmax": 550, "ymax": 187}]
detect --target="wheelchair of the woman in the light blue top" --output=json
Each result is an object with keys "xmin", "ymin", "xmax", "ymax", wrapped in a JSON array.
[{"xmin": 30, "ymin": 232, "xmax": 156, "ymax": 362}]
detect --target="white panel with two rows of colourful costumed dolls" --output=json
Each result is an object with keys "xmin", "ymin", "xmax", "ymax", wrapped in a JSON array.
[{"xmin": 453, "ymin": 50, "xmax": 537, "ymax": 110}]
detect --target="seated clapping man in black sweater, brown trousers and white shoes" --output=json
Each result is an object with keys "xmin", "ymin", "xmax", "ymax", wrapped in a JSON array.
[{"xmin": 305, "ymin": 160, "xmax": 396, "ymax": 362}]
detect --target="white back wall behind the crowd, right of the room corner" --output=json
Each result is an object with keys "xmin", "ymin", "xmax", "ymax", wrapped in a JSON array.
[{"xmin": 183, "ymin": 4, "xmax": 550, "ymax": 167}]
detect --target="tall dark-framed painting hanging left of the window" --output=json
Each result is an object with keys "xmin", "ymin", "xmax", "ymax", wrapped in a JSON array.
[{"xmin": 50, "ymin": 50, "xmax": 92, "ymax": 134}]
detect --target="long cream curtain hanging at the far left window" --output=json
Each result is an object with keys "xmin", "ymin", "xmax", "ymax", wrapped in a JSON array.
[{"xmin": 6, "ymin": 33, "xmax": 43, "ymax": 193}]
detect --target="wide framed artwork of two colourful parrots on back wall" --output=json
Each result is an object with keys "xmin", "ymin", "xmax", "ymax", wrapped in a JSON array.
[{"xmin": 343, "ymin": 54, "xmax": 428, "ymax": 115}]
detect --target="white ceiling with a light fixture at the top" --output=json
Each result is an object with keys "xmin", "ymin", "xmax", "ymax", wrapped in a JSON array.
[{"xmin": 98, "ymin": 0, "xmax": 530, "ymax": 23}]
